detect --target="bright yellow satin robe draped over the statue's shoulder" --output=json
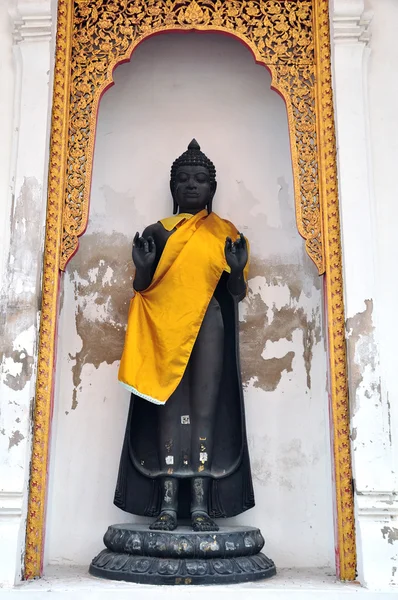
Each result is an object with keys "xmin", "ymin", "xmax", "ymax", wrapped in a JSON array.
[{"xmin": 119, "ymin": 210, "xmax": 246, "ymax": 404}]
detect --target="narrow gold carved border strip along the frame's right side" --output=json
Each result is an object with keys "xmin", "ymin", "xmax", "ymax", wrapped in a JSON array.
[{"xmin": 315, "ymin": 0, "xmax": 356, "ymax": 580}]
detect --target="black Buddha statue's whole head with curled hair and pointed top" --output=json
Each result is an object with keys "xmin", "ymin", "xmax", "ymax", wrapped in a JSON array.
[{"xmin": 170, "ymin": 139, "xmax": 217, "ymax": 214}]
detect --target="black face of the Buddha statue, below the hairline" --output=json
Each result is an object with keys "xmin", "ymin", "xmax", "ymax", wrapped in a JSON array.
[{"xmin": 173, "ymin": 165, "xmax": 215, "ymax": 213}]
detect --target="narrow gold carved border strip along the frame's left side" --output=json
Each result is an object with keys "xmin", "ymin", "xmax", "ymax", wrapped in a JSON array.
[{"xmin": 25, "ymin": 0, "xmax": 72, "ymax": 579}]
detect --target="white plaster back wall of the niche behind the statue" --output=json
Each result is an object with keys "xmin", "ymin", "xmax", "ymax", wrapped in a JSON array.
[{"xmin": 46, "ymin": 34, "xmax": 334, "ymax": 570}]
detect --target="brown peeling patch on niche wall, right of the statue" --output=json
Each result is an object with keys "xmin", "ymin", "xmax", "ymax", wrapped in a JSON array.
[{"xmin": 240, "ymin": 256, "xmax": 322, "ymax": 391}]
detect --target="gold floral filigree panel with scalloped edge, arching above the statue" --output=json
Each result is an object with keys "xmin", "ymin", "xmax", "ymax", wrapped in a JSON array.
[{"xmin": 61, "ymin": 0, "xmax": 324, "ymax": 273}]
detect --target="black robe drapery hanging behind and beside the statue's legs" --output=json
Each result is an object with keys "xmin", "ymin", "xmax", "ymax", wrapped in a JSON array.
[{"xmin": 114, "ymin": 273, "xmax": 254, "ymax": 518}]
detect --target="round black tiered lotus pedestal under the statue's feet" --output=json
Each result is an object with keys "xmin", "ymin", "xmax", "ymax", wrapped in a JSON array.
[{"xmin": 89, "ymin": 524, "xmax": 276, "ymax": 585}]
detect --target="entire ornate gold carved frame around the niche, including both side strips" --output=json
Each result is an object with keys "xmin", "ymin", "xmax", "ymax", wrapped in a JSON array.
[{"xmin": 25, "ymin": 0, "xmax": 356, "ymax": 580}]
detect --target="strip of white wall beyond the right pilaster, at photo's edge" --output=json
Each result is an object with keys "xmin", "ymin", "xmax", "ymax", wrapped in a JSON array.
[{"xmin": 365, "ymin": 0, "xmax": 398, "ymax": 480}]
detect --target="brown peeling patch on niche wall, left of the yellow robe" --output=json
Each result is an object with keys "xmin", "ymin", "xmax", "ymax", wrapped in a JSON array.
[{"xmin": 68, "ymin": 233, "xmax": 133, "ymax": 410}]
